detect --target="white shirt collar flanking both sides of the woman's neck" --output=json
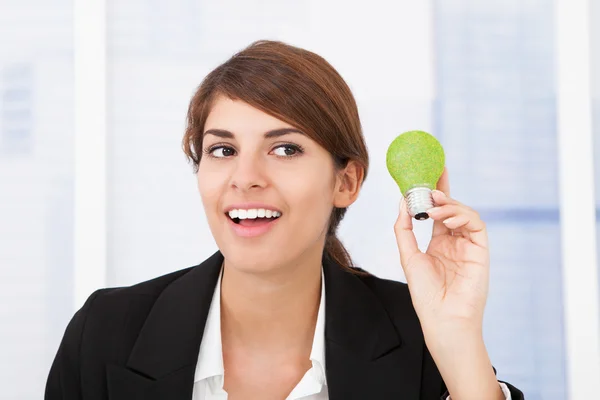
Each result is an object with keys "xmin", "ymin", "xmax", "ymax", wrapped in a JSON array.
[{"xmin": 194, "ymin": 267, "xmax": 326, "ymax": 384}]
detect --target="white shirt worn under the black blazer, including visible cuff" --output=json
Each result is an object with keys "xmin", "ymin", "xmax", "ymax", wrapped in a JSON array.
[{"xmin": 192, "ymin": 270, "xmax": 512, "ymax": 400}]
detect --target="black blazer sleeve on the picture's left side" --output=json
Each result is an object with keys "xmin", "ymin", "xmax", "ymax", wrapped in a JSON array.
[{"xmin": 44, "ymin": 290, "xmax": 102, "ymax": 400}]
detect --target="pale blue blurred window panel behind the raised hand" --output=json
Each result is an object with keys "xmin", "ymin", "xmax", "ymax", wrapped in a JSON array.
[{"xmin": 434, "ymin": 0, "xmax": 566, "ymax": 400}]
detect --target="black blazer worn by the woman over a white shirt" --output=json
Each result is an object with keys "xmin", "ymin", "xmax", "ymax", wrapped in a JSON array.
[{"xmin": 45, "ymin": 252, "xmax": 523, "ymax": 400}]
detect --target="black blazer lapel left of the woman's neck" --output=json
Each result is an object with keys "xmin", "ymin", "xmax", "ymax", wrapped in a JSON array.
[{"xmin": 107, "ymin": 252, "xmax": 223, "ymax": 400}]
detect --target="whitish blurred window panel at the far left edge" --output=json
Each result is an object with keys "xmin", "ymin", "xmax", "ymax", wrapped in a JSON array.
[{"xmin": 0, "ymin": 0, "xmax": 73, "ymax": 399}]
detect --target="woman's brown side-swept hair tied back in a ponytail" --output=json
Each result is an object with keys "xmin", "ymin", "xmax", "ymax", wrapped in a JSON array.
[{"xmin": 183, "ymin": 40, "xmax": 369, "ymax": 271}]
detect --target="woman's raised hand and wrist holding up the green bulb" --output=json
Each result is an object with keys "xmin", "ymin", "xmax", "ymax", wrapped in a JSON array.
[{"xmin": 394, "ymin": 169, "xmax": 504, "ymax": 400}]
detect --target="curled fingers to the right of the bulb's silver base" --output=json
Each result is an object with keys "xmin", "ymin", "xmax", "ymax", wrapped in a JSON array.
[{"xmin": 427, "ymin": 200, "xmax": 488, "ymax": 247}]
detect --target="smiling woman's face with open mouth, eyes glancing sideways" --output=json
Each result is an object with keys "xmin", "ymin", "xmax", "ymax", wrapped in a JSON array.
[{"xmin": 197, "ymin": 96, "xmax": 354, "ymax": 272}]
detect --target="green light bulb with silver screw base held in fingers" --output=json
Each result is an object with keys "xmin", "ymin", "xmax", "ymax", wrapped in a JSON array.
[{"xmin": 386, "ymin": 131, "xmax": 446, "ymax": 220}]
